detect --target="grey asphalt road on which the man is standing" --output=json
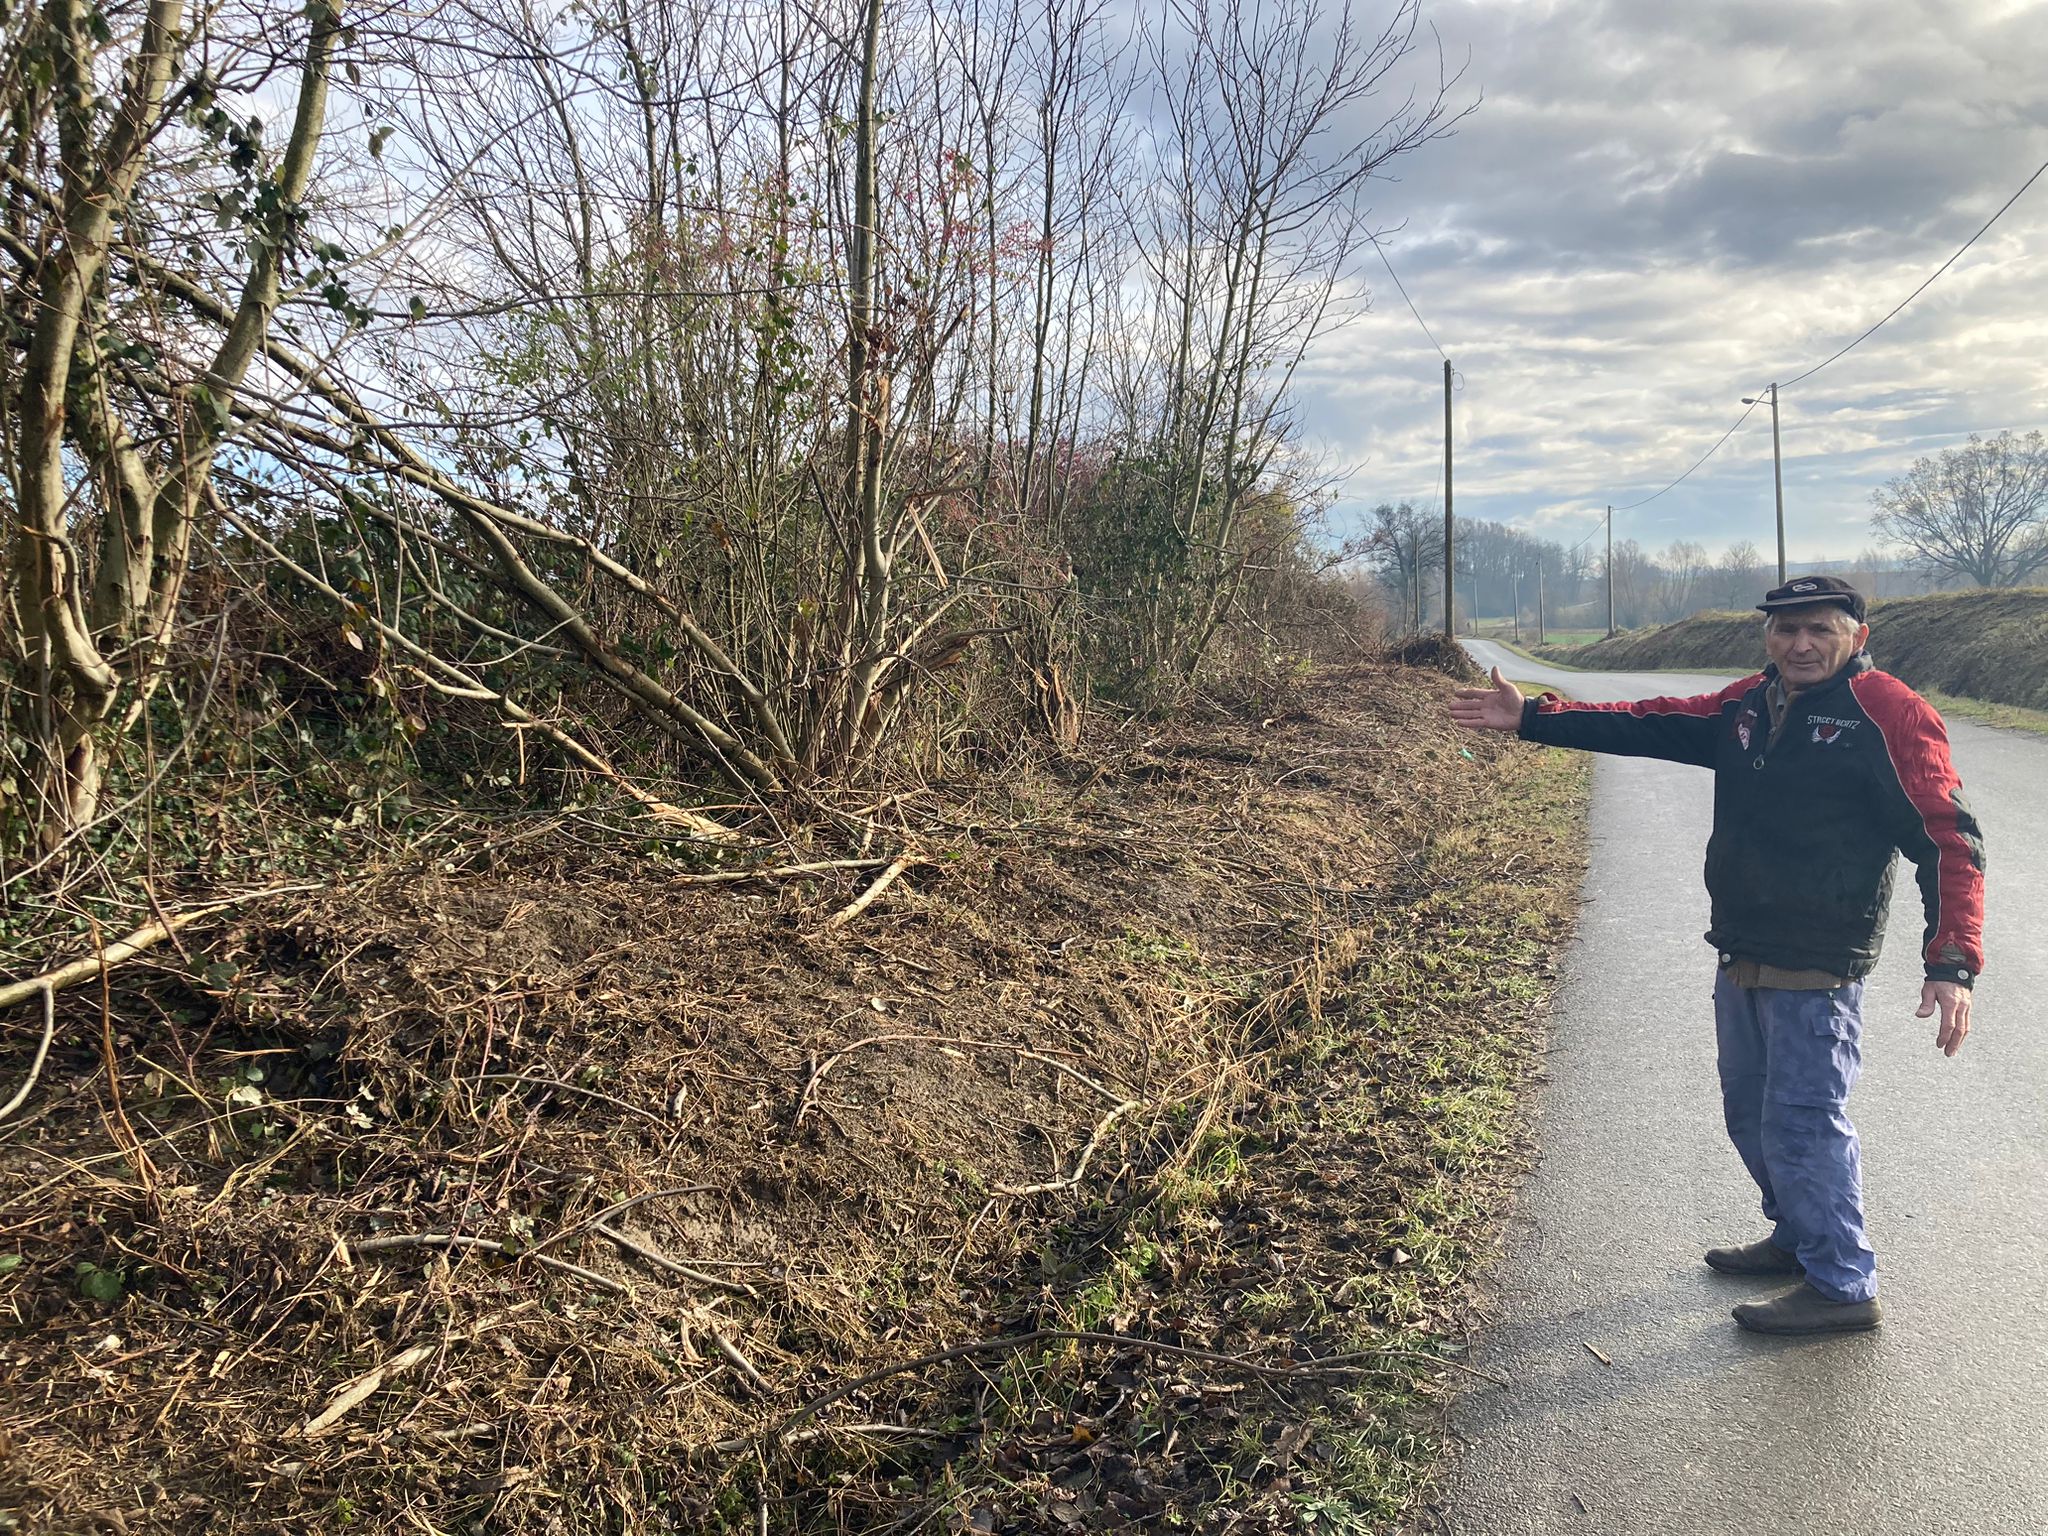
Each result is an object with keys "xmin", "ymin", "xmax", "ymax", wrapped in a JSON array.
[{"xmin": 1438, "ymin": 641, "xmax": 2048, "ymax": 1536}]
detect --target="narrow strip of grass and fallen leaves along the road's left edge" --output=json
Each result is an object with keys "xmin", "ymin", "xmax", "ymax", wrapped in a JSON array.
[{"xmin": 1220, "ymin": 750, "xmax": 1587, "ymax": 1536}]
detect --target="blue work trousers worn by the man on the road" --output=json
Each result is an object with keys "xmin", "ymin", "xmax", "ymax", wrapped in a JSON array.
[{"xmin": 1714, "ymin": 973, "xmax": 1878, "ymax": 1300}]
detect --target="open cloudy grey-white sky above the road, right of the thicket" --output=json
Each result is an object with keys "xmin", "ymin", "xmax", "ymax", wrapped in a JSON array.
[{"xmin": 1300, "ymin": 0, "xmax": 2048, "ymax": 561}]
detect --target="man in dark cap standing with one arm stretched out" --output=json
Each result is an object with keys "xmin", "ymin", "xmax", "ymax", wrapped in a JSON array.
[{"xmin": 1450, "ymin": 575, "xmax": 1985, "ymax": 1333}]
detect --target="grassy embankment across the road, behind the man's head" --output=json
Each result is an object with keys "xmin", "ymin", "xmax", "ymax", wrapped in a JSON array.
[{"xmin": 1530, "ymin": 588, "xmax": 2048, "ymax": 729}]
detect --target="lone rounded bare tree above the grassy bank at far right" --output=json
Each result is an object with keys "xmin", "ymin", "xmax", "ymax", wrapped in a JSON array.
[{"xmin": 1870, "ymin": 430, "xmax": 2048, "ymax": 586}]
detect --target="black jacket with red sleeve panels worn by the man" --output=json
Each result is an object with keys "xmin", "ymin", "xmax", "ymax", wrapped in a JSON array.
[{"xmin": 1522, "ymin": 651, "xmax": 1985, "ymax": 985}]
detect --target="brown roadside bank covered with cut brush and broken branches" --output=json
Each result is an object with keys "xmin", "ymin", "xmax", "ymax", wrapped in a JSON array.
[{"xmin": 0, "ymin": 668, "xmax": 1575, "ymax": 1534}]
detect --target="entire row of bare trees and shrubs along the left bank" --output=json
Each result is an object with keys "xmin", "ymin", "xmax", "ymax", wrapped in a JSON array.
[{"xmin": 0, "ymin": 0, "xmax": 1452, "ymax": 868}]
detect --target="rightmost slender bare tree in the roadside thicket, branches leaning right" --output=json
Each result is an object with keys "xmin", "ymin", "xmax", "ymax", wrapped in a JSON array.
[{"xmin": 1077, "ymin": 0, "xmax": 1456, "ymax": 692}]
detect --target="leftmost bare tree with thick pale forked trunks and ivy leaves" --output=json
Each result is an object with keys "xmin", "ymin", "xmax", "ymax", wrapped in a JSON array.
[{"xmin": 0, "ymin": 0, "xmax": 342, "ymax": 842}]
